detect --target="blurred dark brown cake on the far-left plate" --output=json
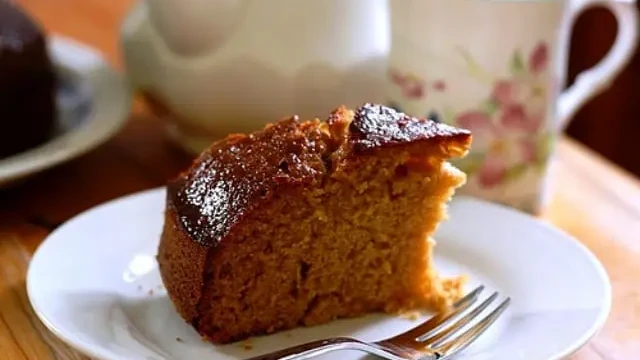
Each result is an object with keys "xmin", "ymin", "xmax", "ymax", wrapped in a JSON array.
[{"xmin": 0, "ymin": 0, "xmax": 56, "ymax": 158}]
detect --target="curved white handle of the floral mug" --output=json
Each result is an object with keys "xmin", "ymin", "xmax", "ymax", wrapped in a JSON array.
[{"xmin": 556, "ymin": 0, "xmax": 638, "ymax": 131}]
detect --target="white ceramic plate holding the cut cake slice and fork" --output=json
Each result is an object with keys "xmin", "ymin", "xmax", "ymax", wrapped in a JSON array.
[{"xmin": 27, "ymin": 189, "xmax": 611, "ymax": 360}]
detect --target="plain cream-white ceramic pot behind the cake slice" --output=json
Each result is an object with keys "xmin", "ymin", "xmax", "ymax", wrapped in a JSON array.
[{"xmin": 122, "ymin": 0, "xmax": 390, "ymax": 151}]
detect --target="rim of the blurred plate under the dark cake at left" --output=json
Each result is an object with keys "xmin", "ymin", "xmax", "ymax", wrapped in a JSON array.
[{"xmin": 0, "ymin": 33, "xmax": 133, "ymax": 187}]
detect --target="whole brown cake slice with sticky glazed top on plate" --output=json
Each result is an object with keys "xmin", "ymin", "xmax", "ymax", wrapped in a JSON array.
[{"xmin": 158, "ymin": 104, "xmax": 471, "ymax": 344}]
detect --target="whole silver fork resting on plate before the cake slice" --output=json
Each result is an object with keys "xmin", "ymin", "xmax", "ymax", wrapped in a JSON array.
[{"xmin": 247, "ymin": 285, "xmax": 511, "ymax": 360}]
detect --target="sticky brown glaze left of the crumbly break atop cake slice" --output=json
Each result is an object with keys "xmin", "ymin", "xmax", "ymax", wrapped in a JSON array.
[{"xmin": 168, "ymin": 118, "xmax": 328, "ymax": 246}]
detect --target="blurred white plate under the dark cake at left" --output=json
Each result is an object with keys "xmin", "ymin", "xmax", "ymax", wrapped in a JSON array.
[{"xmin": 0, "ymin": 36, "xmax": 131, "ymax": 186}]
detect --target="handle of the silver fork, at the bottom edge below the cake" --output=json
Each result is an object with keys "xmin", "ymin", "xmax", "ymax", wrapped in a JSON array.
[{"xmin": 246, "ymin": 337, "xmax": 363, "ymax": 360}]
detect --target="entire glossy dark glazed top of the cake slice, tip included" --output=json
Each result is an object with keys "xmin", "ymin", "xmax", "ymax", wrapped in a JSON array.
[{"xmin": 167, "ymin": 104, "xmax": 470, "ymax": 247}]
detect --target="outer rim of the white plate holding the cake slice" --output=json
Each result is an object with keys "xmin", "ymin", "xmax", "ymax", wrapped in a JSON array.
[{"xmin": 25, "ymin": 186, "xmax": 613, "ymax": 360}]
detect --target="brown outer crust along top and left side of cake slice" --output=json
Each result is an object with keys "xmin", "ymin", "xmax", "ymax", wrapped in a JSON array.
[{"xmin": 158, "ymin": 104, "xmax": 471, "ymax": 343}]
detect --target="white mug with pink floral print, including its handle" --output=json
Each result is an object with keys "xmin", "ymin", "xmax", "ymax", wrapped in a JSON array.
[{"xmin": 387, "ymin": 0, "xmax": 638, "ymax": 213}]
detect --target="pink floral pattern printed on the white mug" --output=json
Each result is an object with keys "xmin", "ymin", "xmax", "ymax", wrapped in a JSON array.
[{"xmin": 391, "ymin": 42, "xmax": 551, "ymax": 189}]
